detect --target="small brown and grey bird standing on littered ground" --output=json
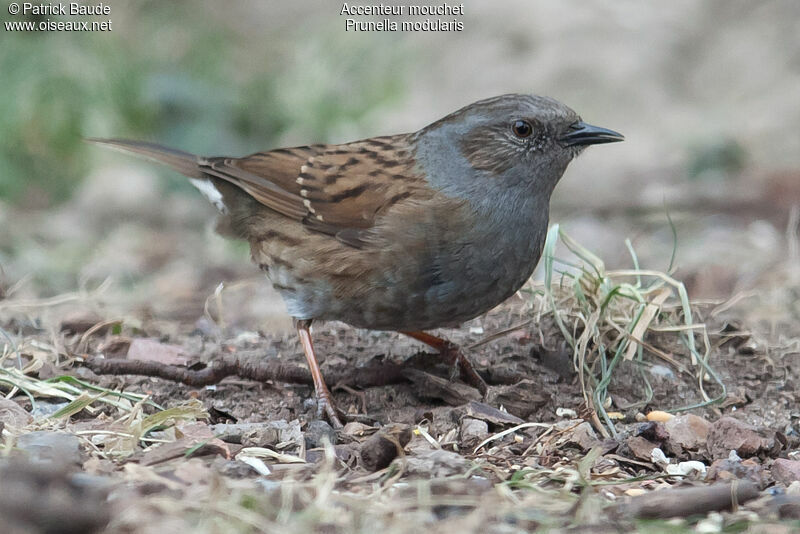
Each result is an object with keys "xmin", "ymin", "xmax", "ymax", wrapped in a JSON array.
[{"xmin": 89, "ymin": 94, "xmax": 624, "ymax": 428}]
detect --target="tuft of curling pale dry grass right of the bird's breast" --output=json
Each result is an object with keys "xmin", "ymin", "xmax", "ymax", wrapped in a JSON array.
[{"xmin": 532, "ymin": 225, "xmax": 725, "ymax": 435}]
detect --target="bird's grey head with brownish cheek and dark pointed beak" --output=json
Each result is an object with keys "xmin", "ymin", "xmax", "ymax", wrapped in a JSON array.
[{"xmin": 417, "ymin": 94, "xmax": 623, "ymax": 201}]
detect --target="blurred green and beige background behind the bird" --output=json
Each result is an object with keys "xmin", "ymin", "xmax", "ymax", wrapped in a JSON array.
[{"xmin": 0, "ymin": 0, "xmax": 800, "ymax": 328}]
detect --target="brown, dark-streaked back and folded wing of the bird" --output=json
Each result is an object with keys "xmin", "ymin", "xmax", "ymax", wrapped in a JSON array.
[{"xmin": 199, "ymin": 134, "xmax": 425, "ymax": 246}]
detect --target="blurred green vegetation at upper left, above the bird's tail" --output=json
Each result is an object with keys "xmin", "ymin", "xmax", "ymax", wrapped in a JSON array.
[{"xmin": 0, "ymin": 2, "xmax": 403, "ymax": 208}]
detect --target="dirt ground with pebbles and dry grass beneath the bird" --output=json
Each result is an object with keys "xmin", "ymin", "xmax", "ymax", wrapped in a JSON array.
[{"xmin": 0, "ymin": 197, "xmax": 800, "ymax": 534}]
